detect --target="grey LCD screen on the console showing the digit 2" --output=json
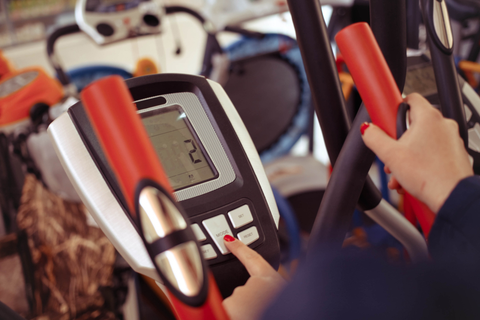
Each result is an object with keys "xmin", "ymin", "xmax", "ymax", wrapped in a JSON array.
[{"xmin": 140, "ymin": 106, "xmax": 217, "ymax": 190}]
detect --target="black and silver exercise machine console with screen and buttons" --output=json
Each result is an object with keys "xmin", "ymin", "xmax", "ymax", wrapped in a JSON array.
[{"xmin": 48, "ymin": 74, "xmax": 280, "ymax": 296}]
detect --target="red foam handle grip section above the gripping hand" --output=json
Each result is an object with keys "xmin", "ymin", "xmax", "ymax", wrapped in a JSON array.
[{"xmin": 335, "ymin": 22, "xmax": 403, "ymax": 138}]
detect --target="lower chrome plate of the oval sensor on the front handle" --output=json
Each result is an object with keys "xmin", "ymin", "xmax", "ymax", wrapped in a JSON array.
[{"xmin": 155, "ymin": 241, "xmax": 204, "ymax": 297}]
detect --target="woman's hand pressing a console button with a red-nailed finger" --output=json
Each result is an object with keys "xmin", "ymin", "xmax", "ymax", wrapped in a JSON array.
[{"xmin": 223, "ymin": 235, "xmax": 286, "ymax": 320}]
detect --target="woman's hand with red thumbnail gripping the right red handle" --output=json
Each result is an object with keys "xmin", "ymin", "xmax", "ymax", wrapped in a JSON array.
[{"xmin": 363, "ymin": 93, "xmax": 473, "ymax": 212}]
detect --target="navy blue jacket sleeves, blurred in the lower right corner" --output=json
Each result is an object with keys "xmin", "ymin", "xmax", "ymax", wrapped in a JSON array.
[{"xmin": 263, "ymin": 177, "xmax": 480, "ymax": 320}]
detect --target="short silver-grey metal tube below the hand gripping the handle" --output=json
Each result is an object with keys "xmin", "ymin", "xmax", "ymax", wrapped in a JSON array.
[{"xmin": 365, "ymin": 199, "xmax": 428, "ymax": 262}]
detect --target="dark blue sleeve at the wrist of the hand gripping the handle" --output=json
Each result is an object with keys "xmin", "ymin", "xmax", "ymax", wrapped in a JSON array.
[{"xmin": 428, "ymin": 176, "xmax": 480, "ymax": 261}]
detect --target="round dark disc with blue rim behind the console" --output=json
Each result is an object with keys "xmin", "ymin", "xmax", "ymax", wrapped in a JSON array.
[{"xmin": 219, "ymin": 34, "xmax": 312, "ymax": 163}]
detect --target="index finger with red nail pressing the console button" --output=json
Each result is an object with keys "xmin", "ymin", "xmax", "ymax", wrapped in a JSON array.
[{"xmin": 223, "ymin": 235, "xmax": 276, "ymax": 276}]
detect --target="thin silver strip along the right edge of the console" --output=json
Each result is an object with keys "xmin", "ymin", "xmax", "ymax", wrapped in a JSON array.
[{"xmin": 207, "ymin": 79, "xmax": 280, "ymax": 229}]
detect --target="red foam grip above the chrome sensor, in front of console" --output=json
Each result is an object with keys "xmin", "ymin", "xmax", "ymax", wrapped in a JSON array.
[{"xmin": 81, "ymin": 76, "xmax": 172, "ymax": 218}]
